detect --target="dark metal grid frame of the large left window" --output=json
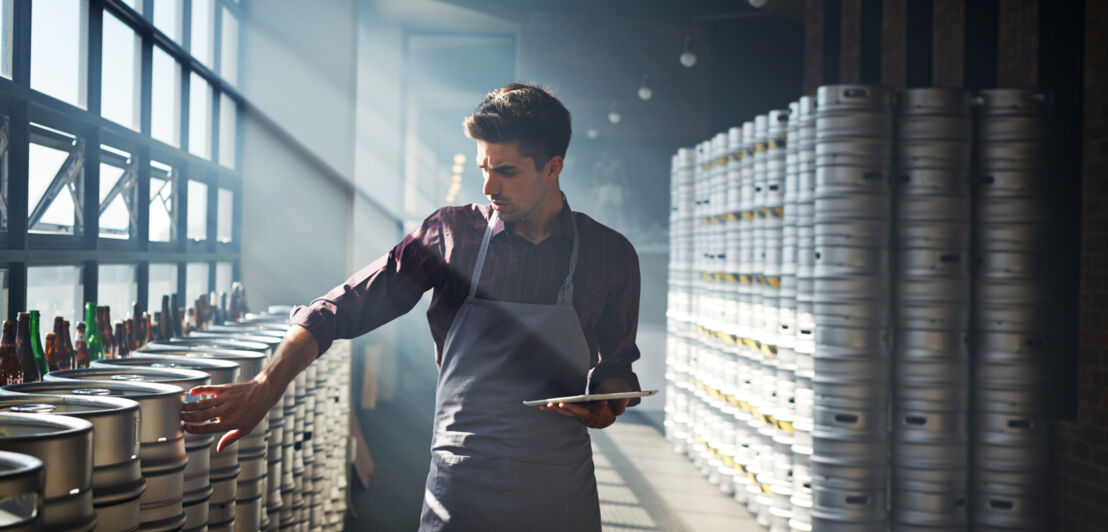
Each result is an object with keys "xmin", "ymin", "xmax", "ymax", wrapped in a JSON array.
[{"xmin": 0, "ymin": 0, "xmax": 248, "ymax": 323}]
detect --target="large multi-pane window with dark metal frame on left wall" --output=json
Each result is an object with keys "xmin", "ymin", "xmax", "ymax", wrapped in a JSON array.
[{"xmin": 0, "ymin": 0, "xmax": 244, "ymax": 327}]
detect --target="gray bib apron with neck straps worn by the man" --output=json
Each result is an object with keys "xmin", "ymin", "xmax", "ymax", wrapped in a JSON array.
[{"xmin": 419, "ymin": 205, "xmax": 601, "ymax": 532}]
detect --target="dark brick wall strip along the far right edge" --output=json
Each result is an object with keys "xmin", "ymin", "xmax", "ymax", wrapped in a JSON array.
[{"xmin": 1054, "ymin": 0, "xmax": 1108, "ymax": 532}]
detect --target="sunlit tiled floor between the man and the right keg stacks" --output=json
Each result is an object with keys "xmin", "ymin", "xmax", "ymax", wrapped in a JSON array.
[{"xmin": 592, "ymin": 411, "xmax": 765, "ymax": 532}]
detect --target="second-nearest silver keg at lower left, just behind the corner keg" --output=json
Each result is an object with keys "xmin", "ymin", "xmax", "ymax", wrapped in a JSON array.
[{"xmin": 0, "ymin": 413, "xmax": 96, "ymax": 531}]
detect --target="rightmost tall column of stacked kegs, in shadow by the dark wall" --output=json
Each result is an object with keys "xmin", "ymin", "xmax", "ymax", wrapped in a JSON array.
[{"xmin": 971, "ymin": 90, "xmax": 1051, "ymax": 530}]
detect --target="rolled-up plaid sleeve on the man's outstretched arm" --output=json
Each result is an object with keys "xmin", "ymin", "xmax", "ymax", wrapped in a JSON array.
[{"xmin": 289, "ymin": 209, "xmax": 447, "ymax": 355}]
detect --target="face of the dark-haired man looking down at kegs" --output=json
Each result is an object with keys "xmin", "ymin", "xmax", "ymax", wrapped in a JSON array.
[{"xmin": 476, "ymin": 141, "xmax": 560, "ymax": 223}]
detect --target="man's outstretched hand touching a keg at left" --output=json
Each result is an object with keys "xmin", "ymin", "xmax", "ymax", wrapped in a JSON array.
[{"xmin": 181, "ymin": 375, "xmax": 284, "ymax": 451}]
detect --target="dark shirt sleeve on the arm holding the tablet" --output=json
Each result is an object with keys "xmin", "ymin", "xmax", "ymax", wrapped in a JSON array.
[{"xmin": 588, "ymin": 241, "xmax": 642, "ymax": 407}]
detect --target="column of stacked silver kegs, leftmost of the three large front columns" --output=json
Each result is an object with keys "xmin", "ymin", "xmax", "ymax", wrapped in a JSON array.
[{"xmin": 811, "ymin": 85, "xmax": 893, "ymax": 530}]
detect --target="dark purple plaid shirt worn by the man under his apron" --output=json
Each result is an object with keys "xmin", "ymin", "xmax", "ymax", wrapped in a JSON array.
[{"xmin": 291, "ymin": 199, "xmax": 640, "ymax": 403}]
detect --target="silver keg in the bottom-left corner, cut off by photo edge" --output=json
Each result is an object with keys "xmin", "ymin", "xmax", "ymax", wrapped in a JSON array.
[{"xmin": 0, "ymin": 451, "xmax": 45, "ymax": 532}]
